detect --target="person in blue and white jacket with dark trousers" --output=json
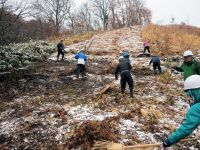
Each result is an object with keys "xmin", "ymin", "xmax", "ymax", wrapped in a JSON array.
[{"xmin": 75, "ymin": 51, "xmax": 87, "ymax": 78}]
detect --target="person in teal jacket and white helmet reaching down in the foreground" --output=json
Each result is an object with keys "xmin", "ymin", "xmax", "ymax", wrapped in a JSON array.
[{"xmin": 163, "ymin": 75, "xmax": 200, "ymax": 148}]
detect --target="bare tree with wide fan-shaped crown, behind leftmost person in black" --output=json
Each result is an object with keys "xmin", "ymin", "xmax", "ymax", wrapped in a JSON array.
[{"xmin": 33, "ymin": 0, "xmax": 71, "ymax": 34}]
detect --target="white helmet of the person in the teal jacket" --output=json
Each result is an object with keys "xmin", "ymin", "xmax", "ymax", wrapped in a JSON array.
[{"xmin": 184, "ymin": 75, "xmax": 200, "ymax": 90}]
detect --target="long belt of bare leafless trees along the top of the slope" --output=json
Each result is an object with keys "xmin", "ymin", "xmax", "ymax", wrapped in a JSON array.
[{"xmin": 0, "ymin": 0, "xmax": 151, "ymax": 44}]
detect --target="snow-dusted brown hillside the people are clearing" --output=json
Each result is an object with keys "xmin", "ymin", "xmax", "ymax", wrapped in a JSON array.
[{"xmin": 0, "ymin": 26, "xmax": 200, "ymax": 150}]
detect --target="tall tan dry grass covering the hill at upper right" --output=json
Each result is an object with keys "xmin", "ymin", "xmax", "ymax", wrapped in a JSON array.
[{"xmin": 142, "ymin": 24, "xmax": 200, "ymax": 55}]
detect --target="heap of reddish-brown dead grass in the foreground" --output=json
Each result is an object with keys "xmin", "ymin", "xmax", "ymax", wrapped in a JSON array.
[{"xmin": 66, "ymin": 117, "xmax": 118, "ymax": 150}]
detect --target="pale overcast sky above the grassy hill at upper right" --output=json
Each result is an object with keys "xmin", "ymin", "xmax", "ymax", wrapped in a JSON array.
[{"xmin": 76, "ymin": 0, "xmax": 200, "ymax": 27}]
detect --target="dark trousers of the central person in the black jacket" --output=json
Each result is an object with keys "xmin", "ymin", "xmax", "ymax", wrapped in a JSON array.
[{"xmin": 120, "ymin": 73, "xmax": 133, "ymax": 97}]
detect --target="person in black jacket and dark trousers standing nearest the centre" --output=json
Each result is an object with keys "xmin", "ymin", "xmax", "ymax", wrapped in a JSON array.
[{"xmin": 115, "ymin": 56, "xmax": 133, "ymax": 98}]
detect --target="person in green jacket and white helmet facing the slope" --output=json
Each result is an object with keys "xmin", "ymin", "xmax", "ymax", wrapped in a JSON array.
[{"xmin": 172, "ymin": 50, "xmax": 200, "ymax": 80}]
